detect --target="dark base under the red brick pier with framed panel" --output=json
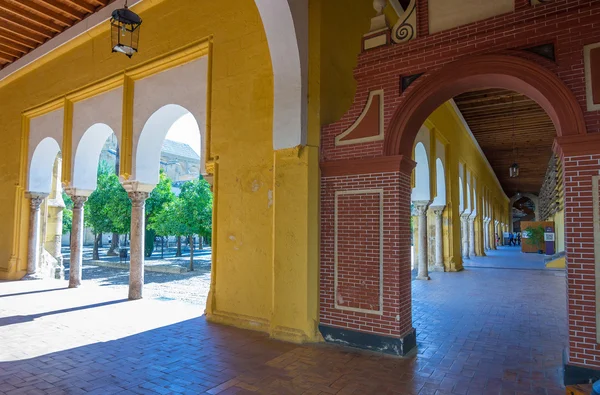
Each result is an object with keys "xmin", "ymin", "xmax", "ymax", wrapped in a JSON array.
[{"xmin": 319, "ymin": 325, "xmax": 417, "ymax": 357}]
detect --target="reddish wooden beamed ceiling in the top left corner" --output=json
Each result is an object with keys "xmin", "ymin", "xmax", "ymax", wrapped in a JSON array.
[{"xmin": 0, "ymin": 0, "xmax": 112, "ymax": 69}]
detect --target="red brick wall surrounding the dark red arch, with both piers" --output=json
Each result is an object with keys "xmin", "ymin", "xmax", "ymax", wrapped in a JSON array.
[{"xmin": 321, "ymin": 0, "xmax": 600, "ymax": 368}]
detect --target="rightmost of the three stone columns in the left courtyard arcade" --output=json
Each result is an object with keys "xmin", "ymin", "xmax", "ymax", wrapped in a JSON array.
[{"xmin": 127, "ymin": 191, "xmax": 148, "ymax": 300}]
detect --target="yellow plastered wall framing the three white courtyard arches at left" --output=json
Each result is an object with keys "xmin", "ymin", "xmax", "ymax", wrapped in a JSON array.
[{"xmin": 0, "ymin": 0, "xmax": 318, "ymax": 340}]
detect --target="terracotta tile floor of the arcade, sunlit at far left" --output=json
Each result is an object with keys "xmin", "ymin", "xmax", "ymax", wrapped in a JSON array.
[{"xmin": 0, "ymin": 252, "xmax": 566, "ymax": 395}]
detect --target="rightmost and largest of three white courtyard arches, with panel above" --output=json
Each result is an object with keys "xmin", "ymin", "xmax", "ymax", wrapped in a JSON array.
[{"xmin": 131, "ymin": 56, "xmax": 208, "ymax": 184}]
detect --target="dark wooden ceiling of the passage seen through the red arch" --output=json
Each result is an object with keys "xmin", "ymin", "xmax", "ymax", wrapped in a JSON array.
[{"xmin": 454, "ymin": 89, "xmax": 556, "ymax": 197}]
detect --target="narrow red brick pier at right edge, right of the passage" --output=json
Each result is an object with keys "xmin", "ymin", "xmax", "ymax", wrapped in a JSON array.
[{"xmin": 563, "ymin": 153, "xmax": 600, "ymax": 368}]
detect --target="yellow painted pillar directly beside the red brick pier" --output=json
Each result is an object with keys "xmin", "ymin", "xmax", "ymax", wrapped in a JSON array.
[{"xmin": 270, "ymin": 146, "xmax": 320, "ymax": 343}]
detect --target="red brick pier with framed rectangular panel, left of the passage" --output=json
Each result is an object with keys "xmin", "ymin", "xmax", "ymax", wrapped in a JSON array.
[{"xmin": 320, "ymin": 172, "xmax": 412, "ymax": 336}]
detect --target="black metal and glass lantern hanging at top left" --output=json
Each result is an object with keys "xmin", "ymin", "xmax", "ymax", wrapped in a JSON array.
[{"xmin": 110, "ymin": 2, "xmax": 142, "ymax": 58}]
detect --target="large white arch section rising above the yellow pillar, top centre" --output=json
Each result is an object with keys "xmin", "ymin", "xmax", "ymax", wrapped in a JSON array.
[{"xmin": 255, "ymin": 0, "xmax": 308, "ymax": 150}]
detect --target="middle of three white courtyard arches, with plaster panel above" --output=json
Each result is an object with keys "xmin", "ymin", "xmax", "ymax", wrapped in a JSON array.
[{"xmin": 70, "ymin": 87, "xmax": 123, "ymax": 191}]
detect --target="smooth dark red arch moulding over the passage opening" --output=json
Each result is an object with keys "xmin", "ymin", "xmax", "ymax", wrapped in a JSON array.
[{"xmin": 384, "ymin": 55, "xmax": 586, "ymax": 155}]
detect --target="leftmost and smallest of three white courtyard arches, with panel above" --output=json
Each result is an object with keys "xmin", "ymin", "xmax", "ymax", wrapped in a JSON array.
[{"xmin": 27, "ymin": 108, "xmax": 64, "ymax": 193}]
